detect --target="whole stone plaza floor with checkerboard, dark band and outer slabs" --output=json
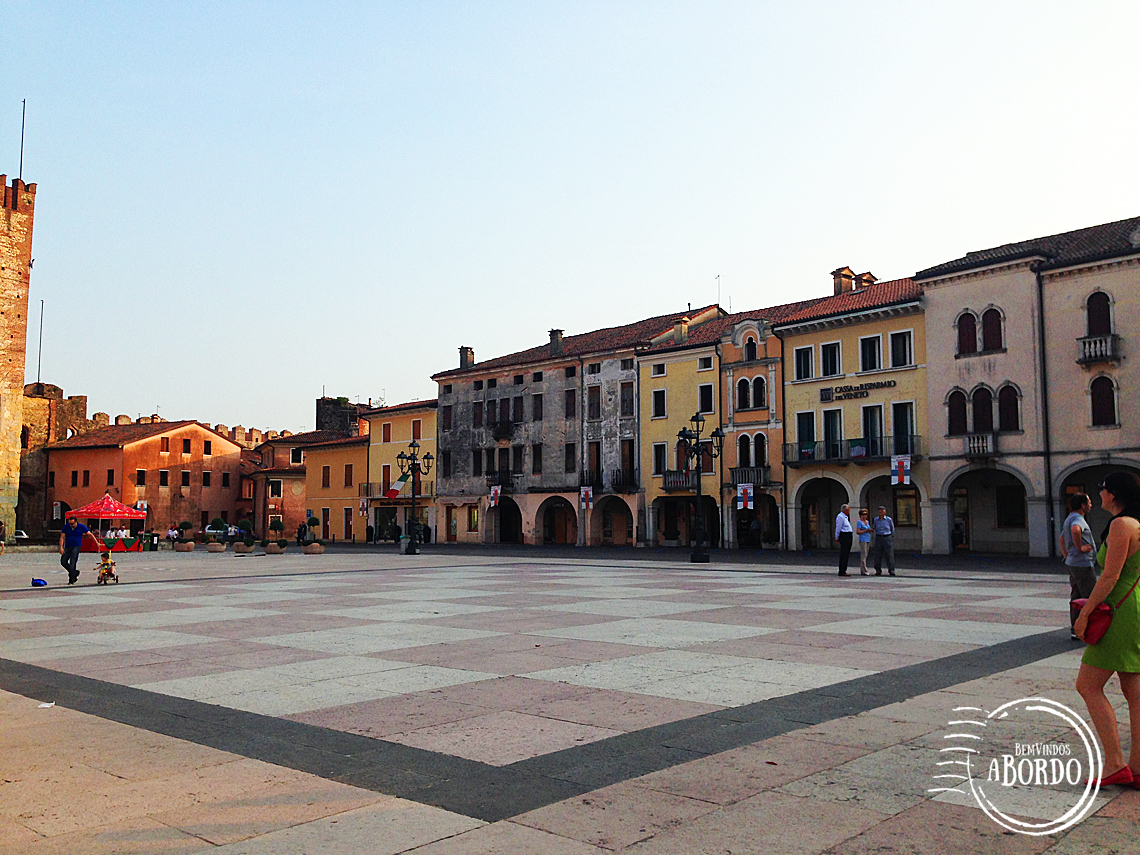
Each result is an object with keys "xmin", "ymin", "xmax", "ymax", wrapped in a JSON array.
[{"xmin": 0, "ymin": 548, "xmax": 1140, "ymax": 855}]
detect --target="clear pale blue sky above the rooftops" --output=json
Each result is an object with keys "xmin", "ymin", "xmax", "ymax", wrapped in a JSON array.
[{"xmin": 0, "ymin": 1, "xmax": 1140, "ymax": 431}]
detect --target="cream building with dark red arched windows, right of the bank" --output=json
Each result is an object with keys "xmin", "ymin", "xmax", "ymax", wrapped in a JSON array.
[{"xmin": 914, "ymin": 218, "xmax": 1140, "ymax": 555}]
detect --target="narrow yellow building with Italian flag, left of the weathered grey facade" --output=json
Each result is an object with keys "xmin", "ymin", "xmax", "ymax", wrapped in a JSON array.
[{"xmin": 359, "ymin": 400, "xmax": 437, "ymax": 542}]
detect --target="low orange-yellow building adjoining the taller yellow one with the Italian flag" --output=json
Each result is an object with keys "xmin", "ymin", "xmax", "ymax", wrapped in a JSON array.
[{"xmin": 303, "ymin": 435, "xmax": 368, "ymax": 543}]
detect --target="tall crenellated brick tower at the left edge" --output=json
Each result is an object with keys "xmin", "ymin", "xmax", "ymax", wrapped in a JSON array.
[{"xmin": 0, "ymin": 176, "xmax": 35, "ymax": 538}]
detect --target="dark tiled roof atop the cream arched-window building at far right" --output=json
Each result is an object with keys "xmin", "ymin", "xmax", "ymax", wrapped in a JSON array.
[{"xmin": 914, "ymin": 217, "xmax": 1140, "ymax": 279}]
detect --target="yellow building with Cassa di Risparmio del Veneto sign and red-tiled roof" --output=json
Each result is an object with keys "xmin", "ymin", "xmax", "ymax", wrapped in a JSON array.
[{"xmin": 774, "ymin": 274, "xmax": 933, "ymax": 552}]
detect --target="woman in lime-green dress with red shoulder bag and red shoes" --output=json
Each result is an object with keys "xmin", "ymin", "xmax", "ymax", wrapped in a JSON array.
[{"xmin": 1073, "ymin": 472, "xmax": 1140, "ymax": 789}]
